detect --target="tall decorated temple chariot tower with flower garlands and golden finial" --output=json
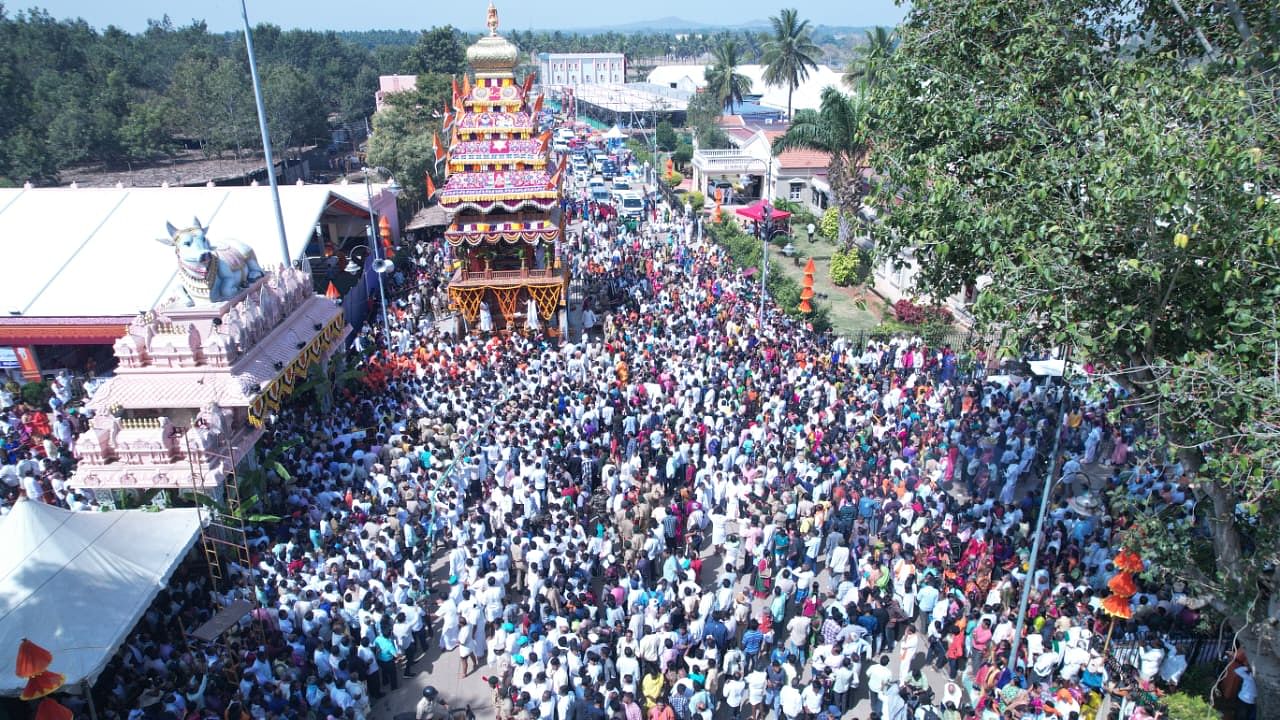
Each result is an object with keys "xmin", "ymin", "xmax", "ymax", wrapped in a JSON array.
[{"xmin": 440, "ymin": 4, "xmax": 566, "ymax": 331}]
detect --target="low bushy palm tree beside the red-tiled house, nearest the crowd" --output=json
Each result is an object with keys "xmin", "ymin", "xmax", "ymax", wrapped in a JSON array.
[{"xmin": 773, "ymin": 87, "xmax": 869, "ymax": 247}]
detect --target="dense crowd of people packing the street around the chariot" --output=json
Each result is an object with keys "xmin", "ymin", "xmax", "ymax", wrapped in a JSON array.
[{"xmin": 18, "ymin": 184, "xmax": 1244, "ymax": 720}]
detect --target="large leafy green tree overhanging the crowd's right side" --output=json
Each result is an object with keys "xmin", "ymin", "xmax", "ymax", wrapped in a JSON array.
[{"xmin": 870, "ymin": 0, "xmax": 1280, "ymax": 696}]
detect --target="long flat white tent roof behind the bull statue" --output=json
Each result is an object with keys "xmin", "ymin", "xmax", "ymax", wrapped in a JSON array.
[{"xmin": 0, "ymin": 184, "xmax": 378, "ymax": 318}]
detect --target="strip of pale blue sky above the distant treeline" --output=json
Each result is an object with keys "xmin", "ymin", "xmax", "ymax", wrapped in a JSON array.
[{"xmin": 10, "ymin": 0, "xmax": 906, "ymax": 32}]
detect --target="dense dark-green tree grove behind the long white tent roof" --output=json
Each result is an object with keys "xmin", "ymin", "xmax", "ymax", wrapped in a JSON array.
[{"xmin": 0, "ymin": 5, "xmax": 389, "ymax": 184}]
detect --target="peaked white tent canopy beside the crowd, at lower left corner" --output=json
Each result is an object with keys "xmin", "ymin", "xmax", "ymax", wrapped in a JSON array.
[{"xmin": 0, "ymin": 501, "xmax": 200, "ymax": 696}]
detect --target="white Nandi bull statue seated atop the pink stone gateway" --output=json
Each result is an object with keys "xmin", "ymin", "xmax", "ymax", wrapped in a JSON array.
[{"xmin": 159, "ymin": 218, "xmax": 262, "ymax": 305}]
